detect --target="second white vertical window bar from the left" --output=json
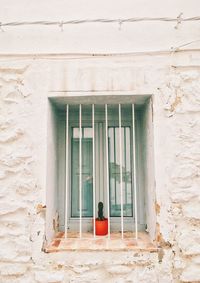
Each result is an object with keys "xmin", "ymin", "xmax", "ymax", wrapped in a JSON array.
[{"xmin": 79, "ymin": 104, "xmax": 82, "ymax": 238}]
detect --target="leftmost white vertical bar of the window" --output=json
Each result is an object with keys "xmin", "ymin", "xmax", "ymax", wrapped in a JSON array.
[{"xmin": 65, "ymin": 104, "xmax": 69, "ymax": 238}]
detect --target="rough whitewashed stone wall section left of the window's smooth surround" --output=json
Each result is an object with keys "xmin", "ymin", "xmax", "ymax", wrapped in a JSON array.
[{"xmin": 0, "ymin": 63, "xmax": 44, "ymax": 282}]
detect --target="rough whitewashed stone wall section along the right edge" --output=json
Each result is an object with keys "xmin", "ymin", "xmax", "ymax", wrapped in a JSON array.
[{"xmin": 158, "ymin": 69, "xmax": 200, "ymax": 282}]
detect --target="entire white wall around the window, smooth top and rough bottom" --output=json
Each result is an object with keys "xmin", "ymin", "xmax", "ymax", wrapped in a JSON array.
[{"xmin": 0, "ymin": 0, "xmax": 200, "ymax": 283}]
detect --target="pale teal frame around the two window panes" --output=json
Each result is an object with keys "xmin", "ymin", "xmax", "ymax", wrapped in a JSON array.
[{"xmin": 68, "ymin": 106, "xmax": 135, "ymax": 231}]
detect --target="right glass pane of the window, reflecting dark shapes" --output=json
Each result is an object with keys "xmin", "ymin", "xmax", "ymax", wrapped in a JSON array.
[{"xmin": 108, "ymin": 127, "xmax": 133, "ymax": 217}]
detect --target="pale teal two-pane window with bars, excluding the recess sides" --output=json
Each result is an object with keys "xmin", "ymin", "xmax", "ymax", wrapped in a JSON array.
[{"xmin": 62, "ymin": 104, "xmax": 144, "ymax": 239}]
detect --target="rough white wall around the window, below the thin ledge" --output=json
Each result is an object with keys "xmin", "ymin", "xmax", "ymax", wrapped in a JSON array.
[{"xmin": 0, "ymin": 53, "xmax": 200, "ymax": 283}]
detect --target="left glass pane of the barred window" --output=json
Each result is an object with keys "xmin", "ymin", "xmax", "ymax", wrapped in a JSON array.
[{"xmin": 71, "ymin": 128, "xmax": 93, "ymax": 217}]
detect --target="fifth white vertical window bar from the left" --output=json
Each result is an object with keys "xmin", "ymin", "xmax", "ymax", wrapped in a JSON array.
[{"xmin": 119, "ymin": 104, "xmax": 124, "ymax": 239}]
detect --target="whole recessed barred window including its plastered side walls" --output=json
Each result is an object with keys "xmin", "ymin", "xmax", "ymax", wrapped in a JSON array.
[{"xmin": 46, "ymin": 94, "xmax": 156, "ymax": 248}]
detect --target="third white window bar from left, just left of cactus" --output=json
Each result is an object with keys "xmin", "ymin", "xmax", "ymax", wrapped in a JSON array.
[{"xmin": 92, "ymin": 104, "xmax": 96, "ymax": 238}]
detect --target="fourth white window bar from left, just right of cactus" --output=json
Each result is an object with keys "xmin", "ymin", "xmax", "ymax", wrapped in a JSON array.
[{"xmin": 105, "ymin": 104, "xmax": 110, "ymax": 239}]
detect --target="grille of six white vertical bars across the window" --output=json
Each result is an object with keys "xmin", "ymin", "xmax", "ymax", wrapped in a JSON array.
[{"xmin": 65, "ymin": 104, "xmax": 138, "ymax": 239}]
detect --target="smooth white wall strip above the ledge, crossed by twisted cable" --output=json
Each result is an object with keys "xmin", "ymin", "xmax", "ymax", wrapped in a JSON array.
[{"xmin": 0, "ymin": 0, "xmax": 200, "ymax": 54}]
